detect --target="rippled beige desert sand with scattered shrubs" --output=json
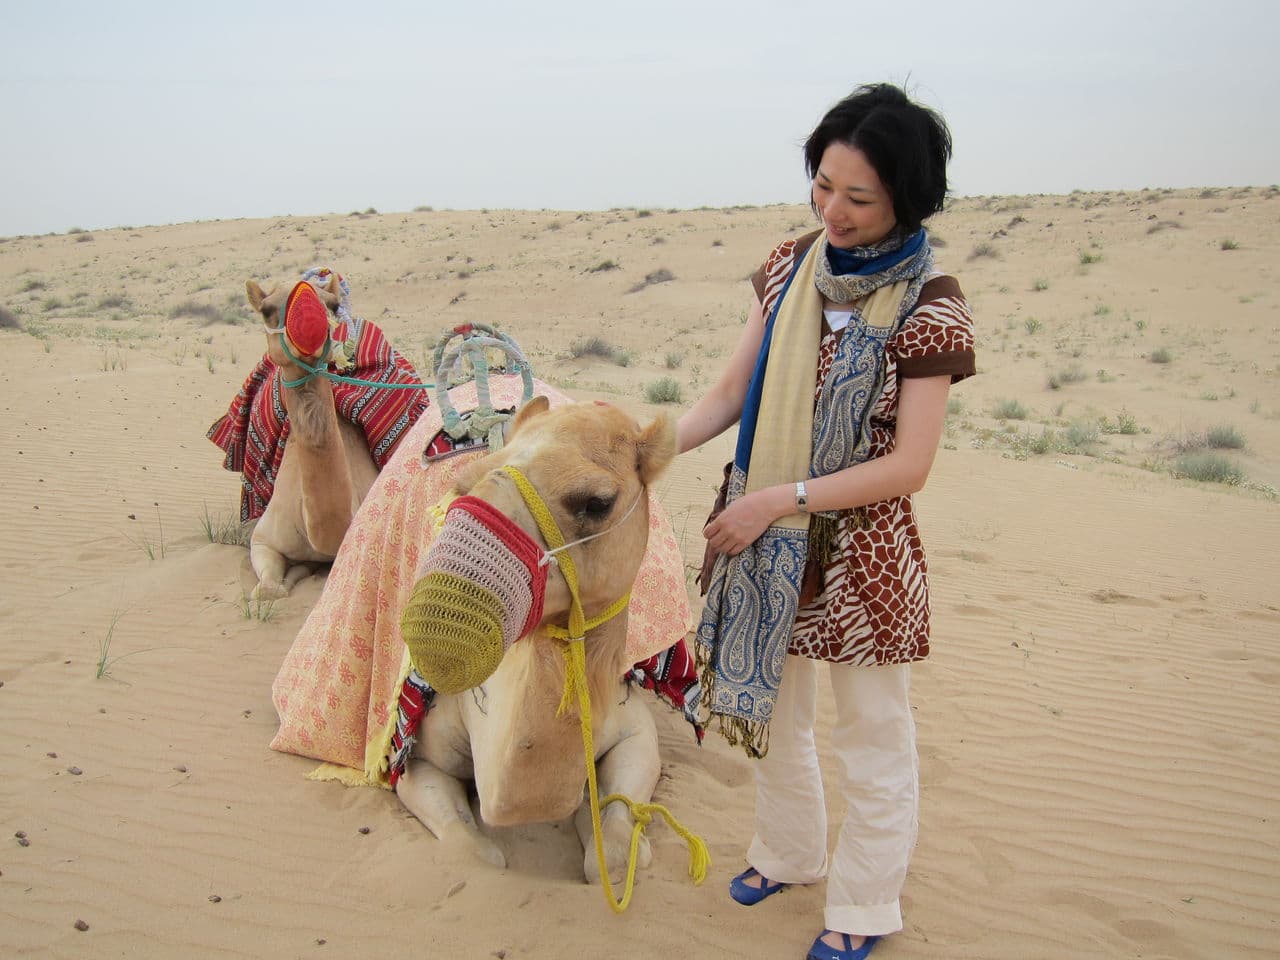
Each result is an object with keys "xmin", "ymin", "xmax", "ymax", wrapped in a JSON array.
[{"xmin": 0, "ymin": 188, "xmax": 1280, "ymax": 960}]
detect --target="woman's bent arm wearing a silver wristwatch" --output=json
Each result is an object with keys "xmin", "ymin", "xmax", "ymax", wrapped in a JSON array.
[{"xmin": 703, "ymin": 375, "xmax": 951, "ymax": 556}]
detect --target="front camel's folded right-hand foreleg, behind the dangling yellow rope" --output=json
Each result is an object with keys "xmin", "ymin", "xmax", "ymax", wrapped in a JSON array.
[{"xmin": 573, "ymin": 700, "xmax": 662, "ymax": 883}]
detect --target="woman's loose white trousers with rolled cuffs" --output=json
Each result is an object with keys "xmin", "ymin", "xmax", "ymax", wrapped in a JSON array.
[{"xmin": 746, "ymin": 655, "xmax": 920, "ymax": 936}]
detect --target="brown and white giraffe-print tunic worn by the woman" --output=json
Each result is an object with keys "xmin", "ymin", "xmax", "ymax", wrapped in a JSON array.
[{"xmin": 753, "ymin": 233, "xmax": 975, "ymax": 666}]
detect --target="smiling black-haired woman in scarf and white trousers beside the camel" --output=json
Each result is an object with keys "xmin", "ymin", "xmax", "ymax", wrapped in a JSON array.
[{"xmin": 678, "ymin": 84, "xmax": 974, "ymax": 960}]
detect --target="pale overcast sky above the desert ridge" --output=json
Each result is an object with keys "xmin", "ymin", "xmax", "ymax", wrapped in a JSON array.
[{"xmin": 0, "ymin": 0, "xmax": 1280, "ymax": 236}]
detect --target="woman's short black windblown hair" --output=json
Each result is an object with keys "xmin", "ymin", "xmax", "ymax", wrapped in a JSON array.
[{"xmin": 804, "ymin": 83, "xmax": 951, "ymax": 233}]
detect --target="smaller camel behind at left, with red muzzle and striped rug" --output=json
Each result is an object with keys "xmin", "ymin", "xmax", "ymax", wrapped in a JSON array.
[{"xmin": 209, "ymin": 269, "xmax": 429, "ymax": 599}]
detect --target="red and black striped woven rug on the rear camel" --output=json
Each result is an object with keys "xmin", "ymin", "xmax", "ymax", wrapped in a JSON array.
[{"xmin": 206, "ymin": 319, "xmax": 430, "ymax": 524}]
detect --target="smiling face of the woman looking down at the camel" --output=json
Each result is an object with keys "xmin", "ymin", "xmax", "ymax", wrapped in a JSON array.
[{"xmin": 813, "ymin": 142, "xmax": 897, "ymax": 250}]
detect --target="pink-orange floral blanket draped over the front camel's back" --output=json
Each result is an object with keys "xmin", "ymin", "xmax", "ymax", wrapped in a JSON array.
[{"xmin": 271, "ymin": 376, "xmax": 699, "ymax": 786}]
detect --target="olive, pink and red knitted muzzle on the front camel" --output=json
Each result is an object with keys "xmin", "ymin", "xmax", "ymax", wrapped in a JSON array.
[{"xmin": 401, "ymin": 497, "xmax": 547, "ymax": 694}]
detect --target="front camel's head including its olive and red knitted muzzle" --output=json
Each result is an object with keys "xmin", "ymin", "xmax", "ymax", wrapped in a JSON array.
[{"xmin": 402, "ymin": 397, "xmax": 676, "ymax": 692}]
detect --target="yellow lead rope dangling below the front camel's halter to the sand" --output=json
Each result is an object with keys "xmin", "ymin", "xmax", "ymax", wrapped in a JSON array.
[{"xmin": 559, "ymin": 637, "xmax": 712, "ymax": 914}]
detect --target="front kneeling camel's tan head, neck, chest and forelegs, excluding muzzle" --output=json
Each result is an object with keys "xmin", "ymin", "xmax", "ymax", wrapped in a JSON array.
[{"xmin": 396, "ymin": 397, "xmax": 676, "ymax": 881}]
